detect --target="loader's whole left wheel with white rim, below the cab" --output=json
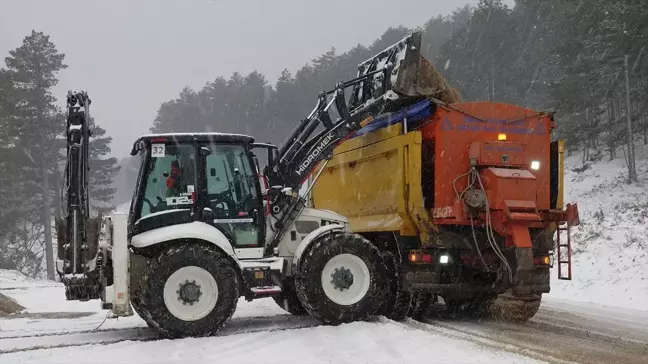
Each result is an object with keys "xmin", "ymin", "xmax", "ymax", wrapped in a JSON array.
[{"xmin": 139, "ymin": 244, "xmax": 240, "ymax": 337}]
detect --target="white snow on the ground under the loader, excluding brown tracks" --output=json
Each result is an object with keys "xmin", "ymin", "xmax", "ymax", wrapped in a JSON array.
[{"xmin": 0, "ymin": 271, "xmax": 540, "ymax": 364}]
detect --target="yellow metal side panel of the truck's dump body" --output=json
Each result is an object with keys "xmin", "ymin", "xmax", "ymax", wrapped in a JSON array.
[{"xmin": 312, "ymin": 129, "xmax": 427, "ymax": 236}]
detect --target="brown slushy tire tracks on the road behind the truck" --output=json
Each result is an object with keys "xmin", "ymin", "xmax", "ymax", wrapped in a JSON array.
[{"xmin": 403, "ymin": 308, "xmax": 648, "ymax": 364}]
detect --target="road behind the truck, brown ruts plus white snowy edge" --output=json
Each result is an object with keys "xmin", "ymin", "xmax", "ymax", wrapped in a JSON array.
[{"xmin": 427, "ymin": 297, "xmax": 648, "ymax": 364}]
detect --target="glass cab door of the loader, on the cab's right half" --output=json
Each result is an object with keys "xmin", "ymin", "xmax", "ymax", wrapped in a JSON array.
[{"xmin": 202, "ymin": 143, "xmax": 265, "ymax": 259}]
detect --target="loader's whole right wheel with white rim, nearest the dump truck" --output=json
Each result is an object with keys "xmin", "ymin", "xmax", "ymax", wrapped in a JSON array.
[{"xmin": 295, "ymin": 232, "xmax": 385, "ymax": 325}]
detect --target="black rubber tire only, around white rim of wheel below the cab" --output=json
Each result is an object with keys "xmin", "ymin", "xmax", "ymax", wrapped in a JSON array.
[{"xmin": 136, "ymin": 243, "xmax": 240, "ymax": 338}]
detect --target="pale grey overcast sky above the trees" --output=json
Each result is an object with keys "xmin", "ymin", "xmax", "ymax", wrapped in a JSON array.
[{"xmin": 0, "ymin": 0, "xmax": 513, "ymax": 157}]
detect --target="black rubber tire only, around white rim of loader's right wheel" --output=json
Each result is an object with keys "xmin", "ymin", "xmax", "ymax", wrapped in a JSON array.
[{"xmin": 295, "ymin": 231, "xmax": 385, "ymax": 325}]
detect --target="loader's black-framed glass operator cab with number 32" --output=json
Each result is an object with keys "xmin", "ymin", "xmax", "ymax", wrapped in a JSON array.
[{"xmin": 128, "ymin": 133, "xmax": 265, "ymax": 249}]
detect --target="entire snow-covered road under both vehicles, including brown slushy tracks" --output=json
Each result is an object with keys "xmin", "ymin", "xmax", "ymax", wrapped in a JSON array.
[{"xmin": 0, "ymin": 278, "xmax": 648, "ymax": 364}]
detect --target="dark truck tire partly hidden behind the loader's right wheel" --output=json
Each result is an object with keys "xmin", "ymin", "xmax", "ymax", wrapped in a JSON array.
[{"xmin": 381, "ymin": 252, "xmax": 412, "ymax": 321}]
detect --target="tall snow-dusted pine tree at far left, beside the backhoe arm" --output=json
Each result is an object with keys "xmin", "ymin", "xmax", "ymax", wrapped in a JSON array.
[{"xmin": 5, "ymin": 31, "xmax": 67, "ymax": 279}]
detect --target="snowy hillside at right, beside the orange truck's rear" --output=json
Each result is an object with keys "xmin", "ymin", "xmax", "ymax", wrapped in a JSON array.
[{"xmin": 548, "ymin": 143, "xmax": 648, "ymax": 311}]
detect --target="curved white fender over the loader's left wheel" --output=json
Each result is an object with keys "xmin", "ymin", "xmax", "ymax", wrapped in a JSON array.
[{"xmin": 130, "ymin": 221, "xmax": 238, "ymax": 262}]
